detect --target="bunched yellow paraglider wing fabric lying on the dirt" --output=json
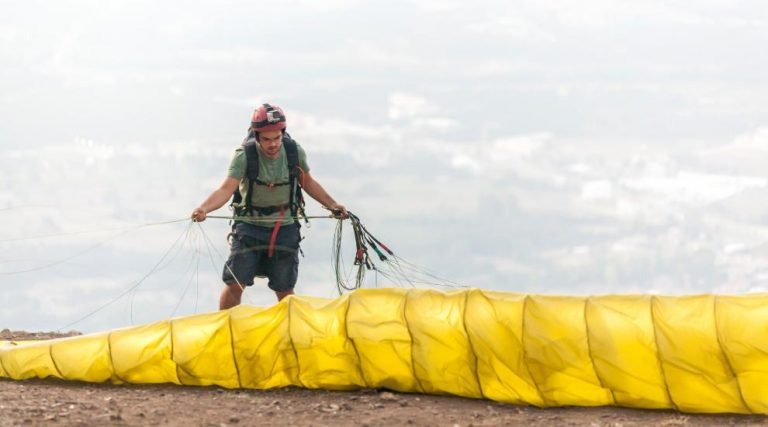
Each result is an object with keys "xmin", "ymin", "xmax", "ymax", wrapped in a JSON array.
[{"xmin": 0, "ymin": 289, "xmax": 768, "ymax": 414}]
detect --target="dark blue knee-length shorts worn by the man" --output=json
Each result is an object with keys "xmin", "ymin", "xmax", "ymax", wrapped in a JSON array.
[{"xmin": 222, "ymin": 223, "xmax": 301, "ymax": 292}]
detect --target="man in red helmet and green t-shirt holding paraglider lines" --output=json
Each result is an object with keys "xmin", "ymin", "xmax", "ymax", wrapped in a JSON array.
[{"xmin": 192, "ymin": 104, "xmax": 347, "ymax": 310}]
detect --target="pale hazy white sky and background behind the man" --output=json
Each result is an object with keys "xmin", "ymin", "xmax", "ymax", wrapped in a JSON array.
[{"xmin": 0, "ymin": 0, "xmax": 768, "ymax": 331}]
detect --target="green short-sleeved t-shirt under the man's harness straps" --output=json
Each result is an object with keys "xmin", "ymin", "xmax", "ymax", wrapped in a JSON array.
[{"xmin": 227, "ymin": 143, "xmax": 309, "ymax": 226}]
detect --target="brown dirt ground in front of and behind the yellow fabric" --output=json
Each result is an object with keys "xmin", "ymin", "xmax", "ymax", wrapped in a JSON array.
[{"xmin": 0, "ymin": 330, "xmax": 768, "ymax": 427}]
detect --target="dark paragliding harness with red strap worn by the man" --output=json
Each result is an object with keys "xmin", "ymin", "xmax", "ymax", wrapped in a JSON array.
[{"xmin": 230, "ymin": 131, "xmax": 309, "ymax": 258}]
